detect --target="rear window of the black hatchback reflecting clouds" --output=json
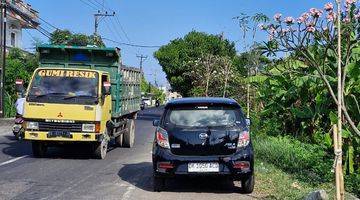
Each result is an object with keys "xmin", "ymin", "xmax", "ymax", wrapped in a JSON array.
[{"xmin": 166, "ymin": 106, "xmax": 241, "ymax": 127}]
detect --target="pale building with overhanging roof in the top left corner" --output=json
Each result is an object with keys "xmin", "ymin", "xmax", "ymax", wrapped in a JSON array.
[{"xmin": 6, "ymin": 0, "xmax": 39, "ymax": 48}]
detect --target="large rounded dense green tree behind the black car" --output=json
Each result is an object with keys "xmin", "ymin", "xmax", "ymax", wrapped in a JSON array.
[{"xmin": 154, "ymin": 31, "xmax": 236, "ymax": 96}]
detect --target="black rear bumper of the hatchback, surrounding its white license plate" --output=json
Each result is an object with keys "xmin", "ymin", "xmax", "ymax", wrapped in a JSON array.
[{"xmin": 153, "ymin": 145, "xmax": 254, "ymax": 179}]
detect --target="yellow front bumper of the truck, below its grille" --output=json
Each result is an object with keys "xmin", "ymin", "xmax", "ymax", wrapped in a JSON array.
[{"xmin": 24, "ymin": 131, "xmax": 97, "ymax": 142}]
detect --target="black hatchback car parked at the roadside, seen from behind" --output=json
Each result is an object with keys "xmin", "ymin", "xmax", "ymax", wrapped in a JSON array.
[{"xmin": 152, "ymin": 98, "xmax": 255, "ymax": 193}]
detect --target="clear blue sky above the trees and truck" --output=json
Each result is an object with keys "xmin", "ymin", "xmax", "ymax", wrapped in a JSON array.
[{"xmin": 23, "ymin": 0, "xmax": 328, "ymax": 86}]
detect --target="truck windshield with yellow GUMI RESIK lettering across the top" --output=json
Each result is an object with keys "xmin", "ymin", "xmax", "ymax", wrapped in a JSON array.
[{"xmin": 28, "ymin": 69, "xmax": 98, "ymax": 104}]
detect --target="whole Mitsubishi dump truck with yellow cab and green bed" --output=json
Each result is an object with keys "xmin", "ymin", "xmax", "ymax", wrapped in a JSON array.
[{"xmin": 18, "ymin": 45, "xmax": 141, "ymax": 159}]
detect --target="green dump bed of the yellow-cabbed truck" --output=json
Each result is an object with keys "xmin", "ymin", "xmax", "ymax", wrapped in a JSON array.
[{"xmin": 37, "ymin": 45, "xmax": 141, "ymax": 118}]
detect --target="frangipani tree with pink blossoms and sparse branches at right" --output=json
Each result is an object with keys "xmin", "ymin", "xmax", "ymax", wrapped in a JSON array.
[{"xmin": 259, "ymin": 0, "xmax": 360, "ymax": 136}]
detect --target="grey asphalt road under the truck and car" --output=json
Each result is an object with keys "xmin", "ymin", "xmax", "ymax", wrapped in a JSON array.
[{"xmin": 0, "ymin": 108, "xmax": 255, "ymax": 200}]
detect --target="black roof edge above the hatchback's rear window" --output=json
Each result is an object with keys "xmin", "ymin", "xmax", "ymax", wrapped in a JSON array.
[{"xmin": 166, "ymin": 97, "xmax": 240, "ymax": 107}]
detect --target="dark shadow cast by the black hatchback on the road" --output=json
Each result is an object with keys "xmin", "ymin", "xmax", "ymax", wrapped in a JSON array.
[{"xmin": 118, "ymin": 162, "xmax": 240, "ymax": 193}]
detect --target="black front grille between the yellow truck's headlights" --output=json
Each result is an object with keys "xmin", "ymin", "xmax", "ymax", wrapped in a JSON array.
[{"xmin": 39, "ymin": 122, "xmax": 82, "ymax": 132}]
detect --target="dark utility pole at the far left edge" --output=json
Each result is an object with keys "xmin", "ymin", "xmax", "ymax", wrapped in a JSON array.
[{"xmin": 0, "ymin": 0, "xmax": 6, "ymax": 118}]
